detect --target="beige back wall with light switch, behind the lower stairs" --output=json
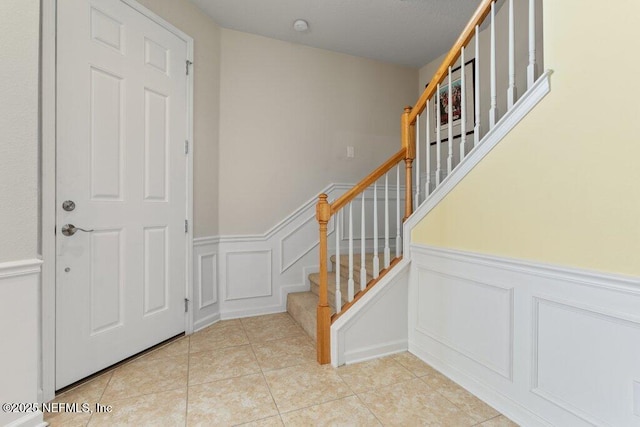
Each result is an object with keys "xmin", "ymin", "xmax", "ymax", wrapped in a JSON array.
[{"xmin": 219, "ymin": 29, "xmax": 418, "ymax": 235}]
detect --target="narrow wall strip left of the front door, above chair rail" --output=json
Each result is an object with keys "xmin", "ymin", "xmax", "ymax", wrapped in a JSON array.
[{"xmin": 0, "ymin": 0, "xmax": 40, "ymax": 262}]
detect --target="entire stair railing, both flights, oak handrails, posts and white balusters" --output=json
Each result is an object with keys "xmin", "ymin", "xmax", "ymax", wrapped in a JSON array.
[{"xmin": 316, "ymin": 0, "xmax": 541, "ymax": 364}]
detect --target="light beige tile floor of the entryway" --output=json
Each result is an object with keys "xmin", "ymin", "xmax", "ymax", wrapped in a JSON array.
[{"xmin": 45, "ymin": 313, "xmax": 515, "ymax": 427}]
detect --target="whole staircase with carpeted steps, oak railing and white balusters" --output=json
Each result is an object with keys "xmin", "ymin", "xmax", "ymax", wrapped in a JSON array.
[{"xmin": 287, "ymin": 0, "xmax": 548, "ymax": 364}]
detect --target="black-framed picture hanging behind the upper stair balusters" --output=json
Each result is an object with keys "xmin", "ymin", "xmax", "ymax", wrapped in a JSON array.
[{"xmin": 430, "ymin": 59, "xmax": 476, "ymax": 145}]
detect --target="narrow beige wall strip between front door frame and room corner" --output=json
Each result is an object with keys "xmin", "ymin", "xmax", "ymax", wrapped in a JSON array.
[{"xmin": 138, "ymin": 0, "xmax": 220, "ymax": 237}]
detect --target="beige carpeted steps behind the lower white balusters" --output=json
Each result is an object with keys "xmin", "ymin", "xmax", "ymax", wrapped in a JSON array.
[{"xmin": 287, "ymin": 253, "xmax": 383, "ymax": 340}]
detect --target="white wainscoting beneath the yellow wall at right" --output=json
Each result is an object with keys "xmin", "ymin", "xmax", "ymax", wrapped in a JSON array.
[{"xmin": 408, "ymin": 245, "xmax": 640, "ymax": 426}]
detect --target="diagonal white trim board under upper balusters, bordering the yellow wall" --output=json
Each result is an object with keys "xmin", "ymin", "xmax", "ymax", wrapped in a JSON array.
[{"xmin": 403, "ymin": 70, "xmax": 553, "ymax": 255}]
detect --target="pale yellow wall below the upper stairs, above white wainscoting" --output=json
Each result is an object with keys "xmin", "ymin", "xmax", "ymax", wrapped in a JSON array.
[{"xmin": 412, "ymin": 0, "xmax": 640, "ymax": 276}]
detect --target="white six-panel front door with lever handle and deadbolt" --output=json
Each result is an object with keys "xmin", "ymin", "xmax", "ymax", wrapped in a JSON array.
[{"xmin": 56, "ymin": 0, "xmax": 188, "ymax": 389}]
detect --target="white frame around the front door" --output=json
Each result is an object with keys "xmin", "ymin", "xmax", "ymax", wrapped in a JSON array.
[{"xmin": 38, "ymin": 0, "xmax": 194, "ymax": 402}]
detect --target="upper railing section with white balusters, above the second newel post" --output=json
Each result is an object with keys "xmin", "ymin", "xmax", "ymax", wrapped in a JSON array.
[{"xmin": 409, "ymin": 0, "xmax": 541, "ymax": 207}]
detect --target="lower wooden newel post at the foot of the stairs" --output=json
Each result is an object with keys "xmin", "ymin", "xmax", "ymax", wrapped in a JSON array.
[{"xmin": 316, "ymin": 194, "xmax": 331, "ymax": 365}]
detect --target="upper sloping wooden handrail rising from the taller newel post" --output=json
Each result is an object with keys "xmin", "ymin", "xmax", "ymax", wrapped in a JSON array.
[{"xmin": 409, "ymin": 0, "xmax": 496, "ymax": 123}]
